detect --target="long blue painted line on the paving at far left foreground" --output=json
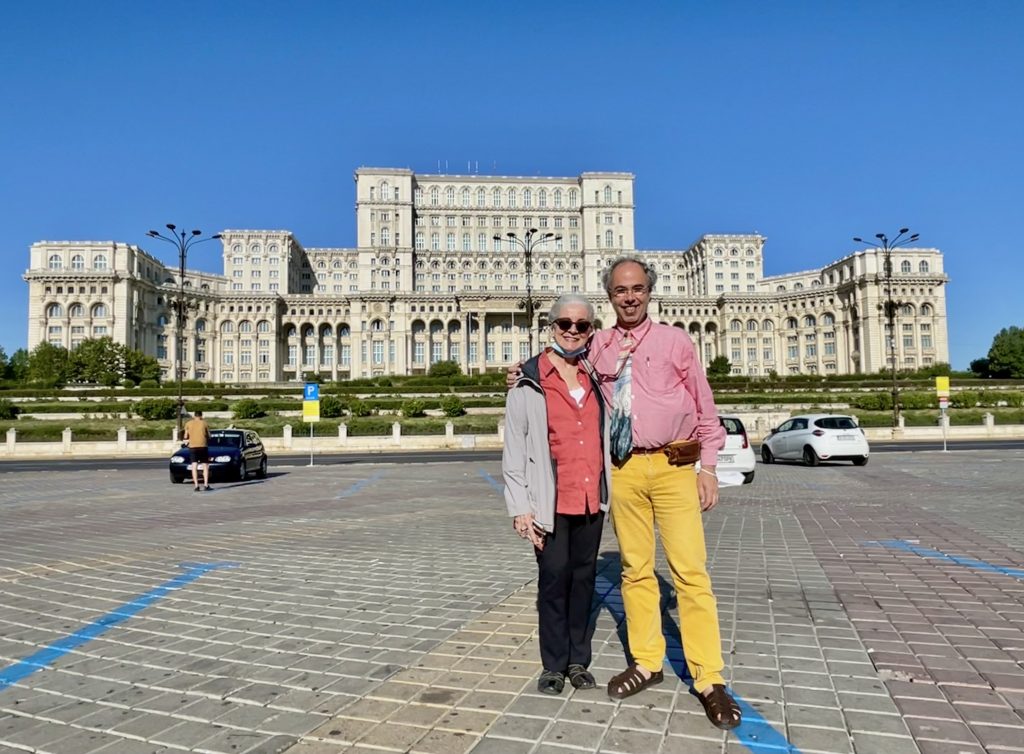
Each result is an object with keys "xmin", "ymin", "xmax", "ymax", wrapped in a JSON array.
[{"xmin": 0, "ymin": 562, "xmax": 238, "ymax": 692}]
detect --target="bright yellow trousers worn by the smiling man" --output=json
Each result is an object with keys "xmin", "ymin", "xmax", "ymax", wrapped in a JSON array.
[{"xmin": 611, "ymin": 453, "xmax": 725, "ymax": 690}]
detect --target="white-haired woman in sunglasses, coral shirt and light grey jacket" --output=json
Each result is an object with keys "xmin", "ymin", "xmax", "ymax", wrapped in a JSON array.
[{"xmin": 502, "ymin": 294, "xmax": 611, "ymax": 694}]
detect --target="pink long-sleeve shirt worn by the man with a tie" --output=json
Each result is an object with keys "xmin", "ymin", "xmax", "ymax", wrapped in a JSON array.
[{"xmin": 589, "ymin": 318, "xmax": 725, "ymax": 466}]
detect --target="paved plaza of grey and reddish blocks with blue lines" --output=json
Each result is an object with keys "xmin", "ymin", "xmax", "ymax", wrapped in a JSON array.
[{"xmin": 0, "ymin": 451, "xmax": 1024, "ymax": 754}]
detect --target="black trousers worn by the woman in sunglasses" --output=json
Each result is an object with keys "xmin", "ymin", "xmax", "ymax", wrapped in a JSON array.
[{"xmin": 535, "ymin": 510, "xmax": 604, "ymax": 673}]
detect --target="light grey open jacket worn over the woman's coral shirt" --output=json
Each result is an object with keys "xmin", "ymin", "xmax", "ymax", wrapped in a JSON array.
[{"xmin": 502, "ymin": 355, "xmax": 611, "ymax": 532}]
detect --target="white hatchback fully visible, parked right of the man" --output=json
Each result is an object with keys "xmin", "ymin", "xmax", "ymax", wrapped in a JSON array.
[{"xmin": 761, "ymin": 414, "xmax": 870, "ymax": 466}]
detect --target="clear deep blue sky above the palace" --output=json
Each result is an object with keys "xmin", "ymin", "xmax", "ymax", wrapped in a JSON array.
[{"xmin": 0, "ymin": 0, "xmax": 1024, "ymax": 368}]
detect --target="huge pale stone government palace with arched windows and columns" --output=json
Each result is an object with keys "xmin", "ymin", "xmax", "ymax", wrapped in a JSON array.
[{"xmin": 25, "ymin": 168, "xmax": 949, "ymax": 383}]
